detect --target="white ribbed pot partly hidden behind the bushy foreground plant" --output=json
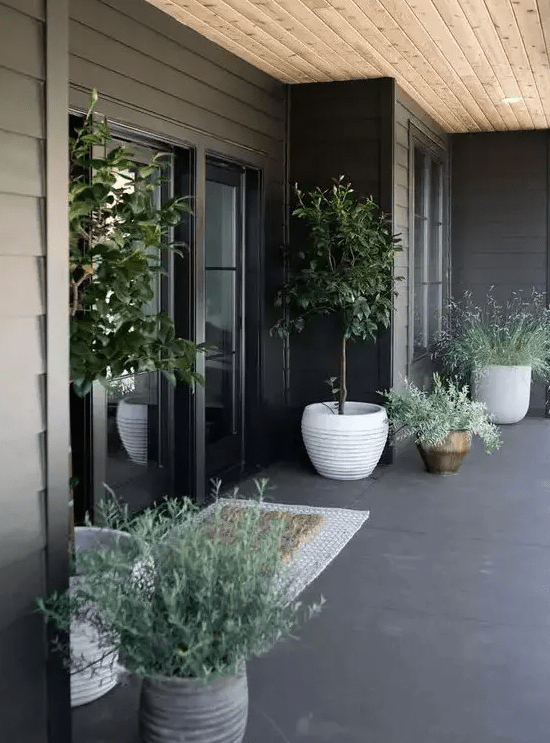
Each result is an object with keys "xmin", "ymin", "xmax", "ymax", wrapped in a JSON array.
[{"xmin": 70, "ymin": 526, "xmax": 127, "ymax": 707}]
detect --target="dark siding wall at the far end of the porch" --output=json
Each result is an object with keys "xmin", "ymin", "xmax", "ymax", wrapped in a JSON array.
[{"xmin": 451, "ymin": 131, "xmax": 549, "ymax": 414}]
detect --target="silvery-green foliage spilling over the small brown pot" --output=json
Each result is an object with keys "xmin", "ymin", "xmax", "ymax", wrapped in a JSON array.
[{"xmin": 384, "ymin": 374, "xmax": 502, "ymax": 453}]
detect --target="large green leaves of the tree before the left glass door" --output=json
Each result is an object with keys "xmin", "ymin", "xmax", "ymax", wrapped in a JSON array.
[{"xmin": 69, "ymin": 91, "xmax": 202, "ymax": 397}]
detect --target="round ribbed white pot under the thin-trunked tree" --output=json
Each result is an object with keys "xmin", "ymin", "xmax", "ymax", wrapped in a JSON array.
[{"xmin": 302, "ymin": 402, "xmax": 388, "ymax": 480}]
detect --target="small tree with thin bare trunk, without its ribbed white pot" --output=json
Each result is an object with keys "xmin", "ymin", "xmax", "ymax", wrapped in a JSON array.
[{"xmin": 271, "ymin": 176, "xmax": 401, "ymax": 410}]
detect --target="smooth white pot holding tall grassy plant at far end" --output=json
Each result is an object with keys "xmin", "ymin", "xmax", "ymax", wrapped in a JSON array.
[{"xmin": 472, "ymin": 366, "xmax": 531, "ymax": 423}]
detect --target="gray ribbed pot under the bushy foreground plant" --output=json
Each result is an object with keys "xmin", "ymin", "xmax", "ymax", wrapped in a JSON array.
[{"xmin": 139, "ymin": 671, "xmax": 248, "ymax": 743}]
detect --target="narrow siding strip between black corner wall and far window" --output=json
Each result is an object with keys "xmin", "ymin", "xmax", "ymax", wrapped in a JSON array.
[{"xmin": 393, "ymin": 86, "xmax": 449, "ymax": 387}]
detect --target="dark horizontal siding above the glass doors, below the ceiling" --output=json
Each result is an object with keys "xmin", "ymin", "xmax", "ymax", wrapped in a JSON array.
[{"xmin": 70, "ymin": 0, "xmax": 285, "ymax": 159}]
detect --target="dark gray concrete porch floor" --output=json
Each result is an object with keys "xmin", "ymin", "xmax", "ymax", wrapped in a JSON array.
[{"xmin": 73, "ymin": 418, "xmax": 550, "ymax": 743}]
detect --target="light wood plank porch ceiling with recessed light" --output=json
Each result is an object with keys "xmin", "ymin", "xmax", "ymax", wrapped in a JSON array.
[{"xmin": 148, "ymin": 0, "xmax": 550, "ymax": 132}]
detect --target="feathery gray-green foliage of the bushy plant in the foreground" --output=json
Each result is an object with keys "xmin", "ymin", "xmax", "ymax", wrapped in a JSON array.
[{"xmin": 37, "ymin": 483, "xmax": 324, "ymax": 682}]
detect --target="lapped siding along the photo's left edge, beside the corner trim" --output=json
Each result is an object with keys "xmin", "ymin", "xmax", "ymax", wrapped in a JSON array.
[{"xmin": 0, "ymin": 0, "xmax": 47, "ymax": 743}]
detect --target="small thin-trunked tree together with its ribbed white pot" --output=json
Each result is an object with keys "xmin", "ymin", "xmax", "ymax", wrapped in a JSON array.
[{"xmin": 271, "ymin": 176, "xmax": 400, "ymax": 480}]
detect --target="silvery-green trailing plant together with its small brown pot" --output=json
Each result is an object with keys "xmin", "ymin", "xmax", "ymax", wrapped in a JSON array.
[{"xmin": 384, "ymin": 373, "xmax": 501, "ymax": 474}]
